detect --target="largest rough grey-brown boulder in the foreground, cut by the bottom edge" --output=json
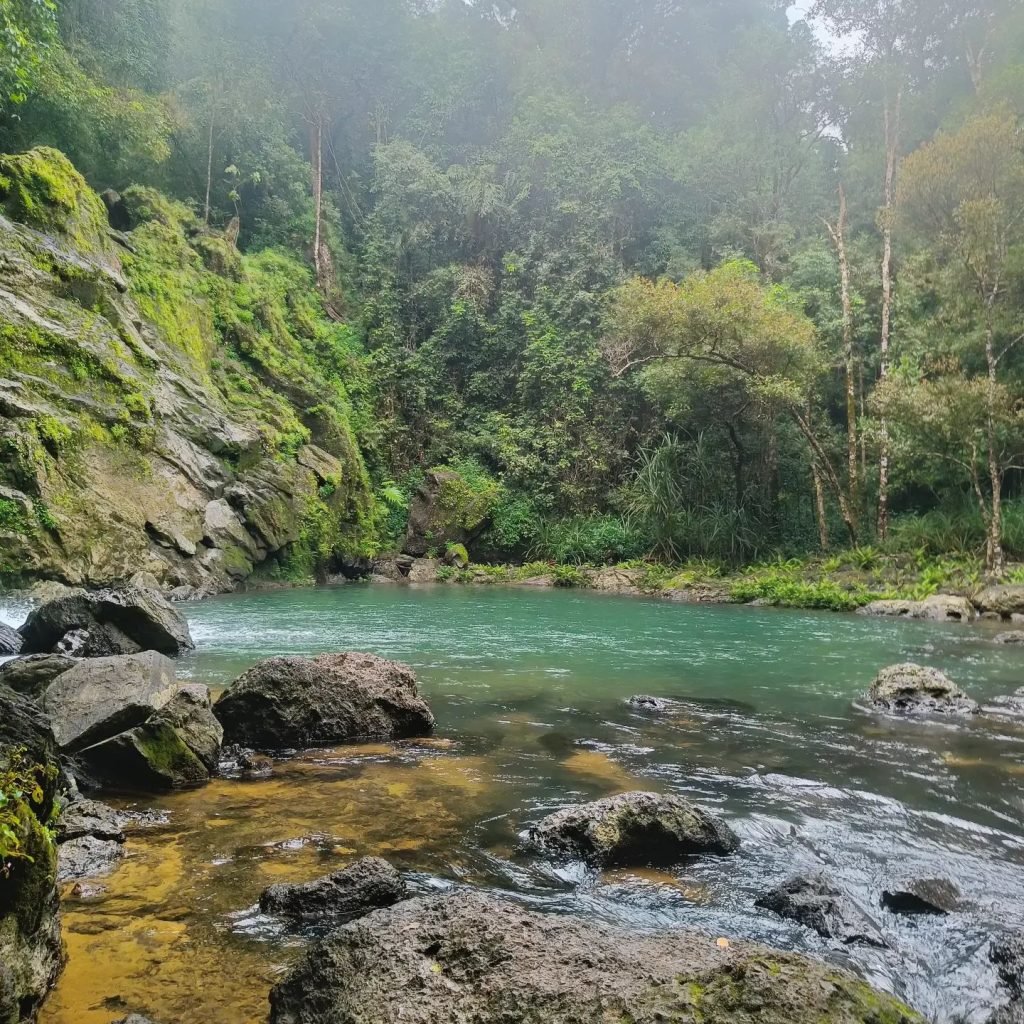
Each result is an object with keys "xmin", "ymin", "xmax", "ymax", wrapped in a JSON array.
[{"xmin": 270, "ymin": 892, "xmax": 924, "ymax": 1024}]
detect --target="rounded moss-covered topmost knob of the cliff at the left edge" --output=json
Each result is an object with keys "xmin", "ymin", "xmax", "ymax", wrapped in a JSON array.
[{"xmin": 0, "ymin": 146, "xmax": 108, "ymax": 251}]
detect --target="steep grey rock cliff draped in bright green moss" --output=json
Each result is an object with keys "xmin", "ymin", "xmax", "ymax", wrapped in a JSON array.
[{"xmin": 0, "ymin": 150, "xmax": 372, "ymax": 593}]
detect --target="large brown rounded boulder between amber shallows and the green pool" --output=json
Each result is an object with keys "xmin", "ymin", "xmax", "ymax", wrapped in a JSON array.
[{"xmin": 214, "ymin": 653, "xmax": 434, "ymax": 750}]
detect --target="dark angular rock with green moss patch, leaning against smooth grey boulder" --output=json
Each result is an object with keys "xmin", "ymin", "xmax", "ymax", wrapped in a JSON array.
[{"xmin": 79, "ymin": 686, "xmax": 223, "ymax": 793}]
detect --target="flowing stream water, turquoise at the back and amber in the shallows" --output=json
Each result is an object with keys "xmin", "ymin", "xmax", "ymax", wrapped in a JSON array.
[{"xmin": 12, "ymin": 585, "xmax": 1024, "ymax": 1024}]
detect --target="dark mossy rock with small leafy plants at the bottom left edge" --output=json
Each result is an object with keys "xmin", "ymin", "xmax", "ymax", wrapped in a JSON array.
[{"xmin": 0, "ymin": 687, "xmax": 65, "ymax": 1024}]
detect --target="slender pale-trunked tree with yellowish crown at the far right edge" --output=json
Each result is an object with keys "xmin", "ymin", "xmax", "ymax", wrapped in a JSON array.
[{"xmin": 899, "ymin": 112, "xmax": 1024, "ymax": 574}]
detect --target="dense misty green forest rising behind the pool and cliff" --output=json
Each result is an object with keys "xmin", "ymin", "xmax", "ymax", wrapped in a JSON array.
[{"xmin": 0, "ymin": 0, "xmax": 1024, "ymax": 572}]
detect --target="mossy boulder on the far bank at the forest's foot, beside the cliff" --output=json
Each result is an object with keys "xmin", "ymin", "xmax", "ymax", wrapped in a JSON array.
[{"xmin": 402, "ymin": 469, "xmax": 489, "ymax": 558}]
